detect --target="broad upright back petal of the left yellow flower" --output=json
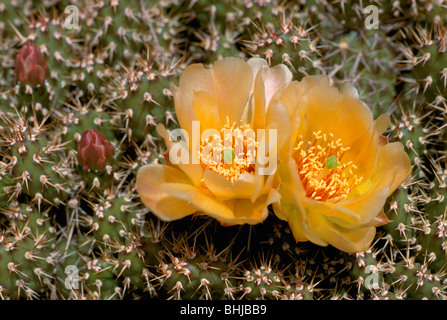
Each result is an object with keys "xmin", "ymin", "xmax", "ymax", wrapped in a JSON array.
[{"xmin": 174, "ymin": 57, "xmax": 253, "ymax": 132}]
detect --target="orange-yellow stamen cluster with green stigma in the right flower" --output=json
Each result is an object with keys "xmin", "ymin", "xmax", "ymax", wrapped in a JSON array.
[{"xmin": 293, "ymin": 131, "xmax": 363, "ymax": 202}]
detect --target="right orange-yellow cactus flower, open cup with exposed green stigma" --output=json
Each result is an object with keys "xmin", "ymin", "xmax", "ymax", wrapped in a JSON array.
[{"xmin": 271, "ymin": 76, "xmax": 411, "ymax": 252}]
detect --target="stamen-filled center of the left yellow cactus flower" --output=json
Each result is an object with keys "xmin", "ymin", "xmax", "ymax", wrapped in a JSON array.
[{"xmin": 200, "ymin": 118, "xmax": 257, "ymax": 182}]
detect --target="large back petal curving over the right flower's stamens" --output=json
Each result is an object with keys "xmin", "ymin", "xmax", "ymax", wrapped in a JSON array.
[{"xmin": 280, "ymin": 76, "xmax": 378, "ymax": 176}]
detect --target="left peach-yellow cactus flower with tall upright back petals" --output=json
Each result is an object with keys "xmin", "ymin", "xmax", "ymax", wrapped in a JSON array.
[{"xmin": 136, "ymin": 57, "xmax": 292, "ymax": 225}]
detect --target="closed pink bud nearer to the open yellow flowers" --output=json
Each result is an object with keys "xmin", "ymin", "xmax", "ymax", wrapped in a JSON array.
[{"xmin": 78, "ymin": 129, "xmax": 115, "ymax": 171}]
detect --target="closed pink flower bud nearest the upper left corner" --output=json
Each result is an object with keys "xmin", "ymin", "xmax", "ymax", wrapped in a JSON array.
[{"xmin": 15, "ymin": 41, "xmax": 50, "ymax": 88}]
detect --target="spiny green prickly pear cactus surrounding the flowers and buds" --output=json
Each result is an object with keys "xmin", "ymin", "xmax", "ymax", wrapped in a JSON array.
[{"xmin": 0, "ymin": 0, "xmax": 447, "ymax": 300}]
